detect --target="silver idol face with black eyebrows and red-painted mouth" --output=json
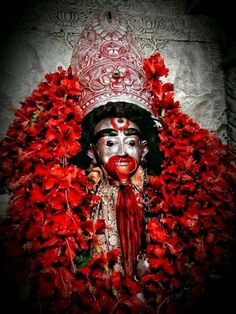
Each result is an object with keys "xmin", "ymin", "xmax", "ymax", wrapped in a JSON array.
[{"xmin": 94, "ymin": 118, "xmax": 147, "ymax": 184}]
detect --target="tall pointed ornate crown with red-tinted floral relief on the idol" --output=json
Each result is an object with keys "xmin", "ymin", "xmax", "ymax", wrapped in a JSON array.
[{"xmin": 71, "ymin": 11, "xmax": 152, "ymax": 115}]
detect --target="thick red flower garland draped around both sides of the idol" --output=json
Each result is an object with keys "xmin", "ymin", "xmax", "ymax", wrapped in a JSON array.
[{"xmin": 0, "ymin": 53, "xmax": 235, "ymax": 313}]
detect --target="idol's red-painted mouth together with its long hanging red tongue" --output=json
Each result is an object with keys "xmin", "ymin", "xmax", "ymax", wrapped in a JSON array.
[{"xmin": 106, "ymin": 156, "xmax": 143, "ymax": 277}]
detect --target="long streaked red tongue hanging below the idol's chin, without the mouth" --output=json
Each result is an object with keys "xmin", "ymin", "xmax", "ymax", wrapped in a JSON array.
[{"xmin": 116, "ymin": 185, "xmax": 143, "ymax": 277}]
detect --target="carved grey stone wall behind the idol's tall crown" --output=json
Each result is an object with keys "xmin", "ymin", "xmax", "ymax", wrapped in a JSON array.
[{"xmin": 0, "ymin": 0, "xmax": 230, "ymax": 145}]
